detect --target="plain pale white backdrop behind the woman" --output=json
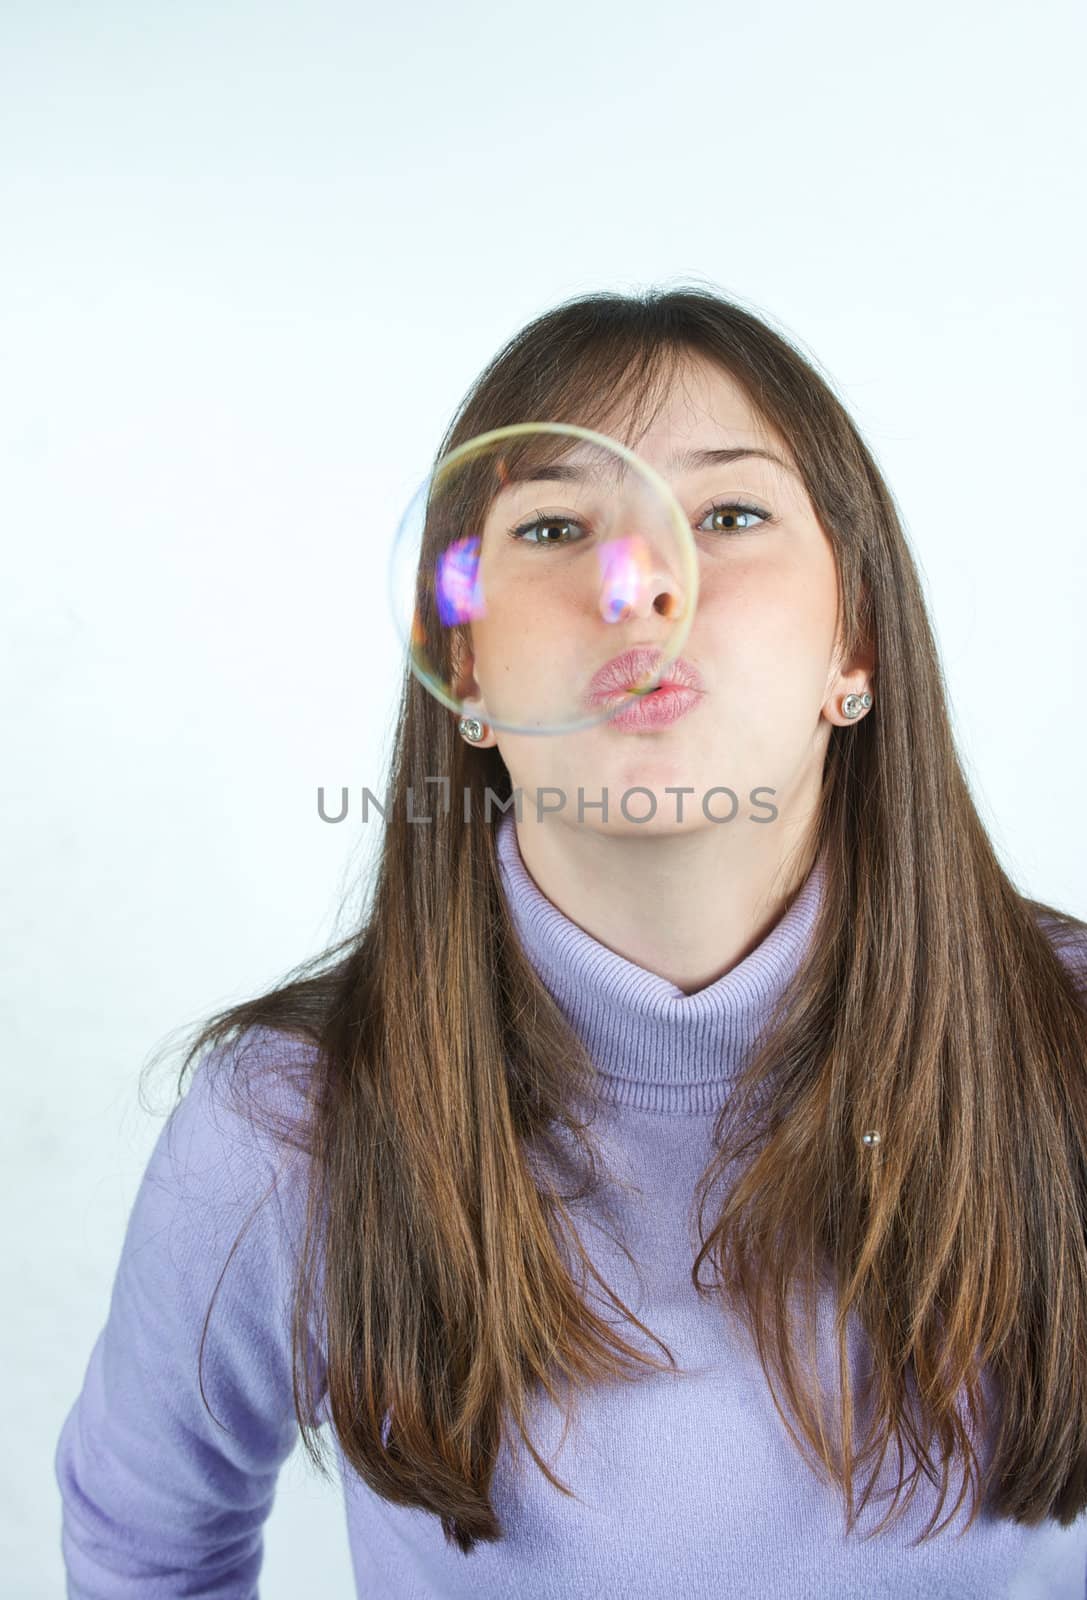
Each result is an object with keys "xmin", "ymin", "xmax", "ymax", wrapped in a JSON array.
[{"xmin": 0, "ymin": 0, "xmax": 1087, "ymax": 1600}]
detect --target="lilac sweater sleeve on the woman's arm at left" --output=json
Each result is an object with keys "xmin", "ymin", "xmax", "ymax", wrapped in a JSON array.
[{"xmin": 54, "ymin": 1046, "xmax": 323, "ymax": 1600}]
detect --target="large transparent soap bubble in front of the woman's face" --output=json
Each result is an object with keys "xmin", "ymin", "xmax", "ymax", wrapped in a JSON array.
[{"xmin": 389, "ymin": 422, "xmax": 698, "ymax": 734}]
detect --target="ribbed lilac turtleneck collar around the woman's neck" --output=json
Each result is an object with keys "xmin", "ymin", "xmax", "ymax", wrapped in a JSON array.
[{"xmin": 496, "ymin": 811, "xmax": 824, "ymax": 1115}]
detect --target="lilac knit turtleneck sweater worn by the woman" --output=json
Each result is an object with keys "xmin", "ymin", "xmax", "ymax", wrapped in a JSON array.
[{"xmin": 56, "ymin": 814, "xmax": 1087, "ymax": 1600}]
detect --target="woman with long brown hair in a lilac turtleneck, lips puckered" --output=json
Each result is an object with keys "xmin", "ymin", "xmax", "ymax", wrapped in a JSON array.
[{"xmin": 56, "ymin": 290, "xmax": 1087, "ymax": 1600}]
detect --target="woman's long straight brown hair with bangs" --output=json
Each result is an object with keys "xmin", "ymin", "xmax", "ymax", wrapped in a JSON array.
[{"xmin": 144, "ymin": 288, "xmax": 1087, "ymax": 1552}]
